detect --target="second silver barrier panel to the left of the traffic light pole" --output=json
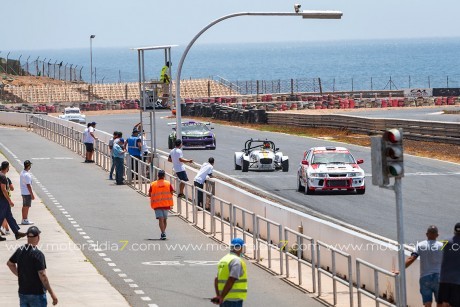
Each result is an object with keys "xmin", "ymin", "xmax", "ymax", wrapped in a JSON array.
[{"xmin": 316, "ymin": 241, "xmax": 353, "ymax": 306}]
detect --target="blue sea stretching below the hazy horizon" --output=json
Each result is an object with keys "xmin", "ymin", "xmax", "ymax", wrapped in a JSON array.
[{"xmin": 10, "ymin": 38, "xmax": 460, "ymax": 90}]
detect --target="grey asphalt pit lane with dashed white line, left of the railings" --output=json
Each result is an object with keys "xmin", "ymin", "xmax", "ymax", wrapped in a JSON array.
[{"xmin": 0, "ymin": 127, "xmax": 322, "ymax": 307}]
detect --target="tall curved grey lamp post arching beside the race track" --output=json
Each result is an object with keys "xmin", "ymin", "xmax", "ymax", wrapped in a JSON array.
[{"xmin": 176, "ymin": 6, "xmax": 343, "ymax": 139}]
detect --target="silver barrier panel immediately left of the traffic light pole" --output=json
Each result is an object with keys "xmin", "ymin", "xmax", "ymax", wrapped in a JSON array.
[{"xmin": 356, "ymin": 258, "xmax": 399, "ymax": 307}]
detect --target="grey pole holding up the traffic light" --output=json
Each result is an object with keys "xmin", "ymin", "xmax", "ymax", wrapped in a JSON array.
[{"xmin": 394, "ymin": 177, "xmax": 407, "ymax": 307}]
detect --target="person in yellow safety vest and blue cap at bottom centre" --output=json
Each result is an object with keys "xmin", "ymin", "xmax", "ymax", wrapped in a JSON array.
[{"xmin": 211, "ymin": 238, "xmax": 248, "ymax": 307}]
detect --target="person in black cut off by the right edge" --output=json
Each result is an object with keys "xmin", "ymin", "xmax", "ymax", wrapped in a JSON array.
[{"xmin": 439, "ymin": 223, "xmax": 460, "ymax": 307}]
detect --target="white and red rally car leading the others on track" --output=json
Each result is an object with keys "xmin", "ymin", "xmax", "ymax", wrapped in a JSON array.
[{"xmin": 297, "ymin": 147, "xmax": 366, "ymax": 194}]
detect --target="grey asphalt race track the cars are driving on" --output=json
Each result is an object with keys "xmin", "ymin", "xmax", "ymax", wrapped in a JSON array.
[{"xmin": 89, "ymin": 107, "xmax": 460, "ymax": 244}]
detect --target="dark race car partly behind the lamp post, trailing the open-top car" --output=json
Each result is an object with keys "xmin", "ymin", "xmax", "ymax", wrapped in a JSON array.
[{"xmin": 168, "ymin": 121, "xmax": 216, "ymax": 150}]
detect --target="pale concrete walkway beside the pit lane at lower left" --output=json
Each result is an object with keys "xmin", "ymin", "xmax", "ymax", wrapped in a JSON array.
[{"xmin": 0, "ymin": 154, "xmax": 129, "ymax": 307}]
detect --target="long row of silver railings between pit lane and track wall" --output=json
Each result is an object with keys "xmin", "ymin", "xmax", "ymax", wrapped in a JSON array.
[{"xmin": 26, "ymin": 115, "xmax": 404, "ymax": 306}]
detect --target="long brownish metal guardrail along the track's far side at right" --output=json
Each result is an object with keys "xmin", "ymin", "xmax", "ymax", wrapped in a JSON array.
[{"xmin": 267, "ymin": 112, "xmax": 460, "ymax": 145}]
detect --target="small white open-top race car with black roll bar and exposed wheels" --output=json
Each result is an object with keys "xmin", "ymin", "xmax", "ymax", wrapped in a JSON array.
[{"xmin": 235, "ymin": 139, "xmax": 289, "ymax": 172}]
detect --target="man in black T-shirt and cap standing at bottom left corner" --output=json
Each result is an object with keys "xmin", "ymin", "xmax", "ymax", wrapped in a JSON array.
[{"xmin": 6, "ymin": 226, "xmax": 58, "ymax": 307}]
